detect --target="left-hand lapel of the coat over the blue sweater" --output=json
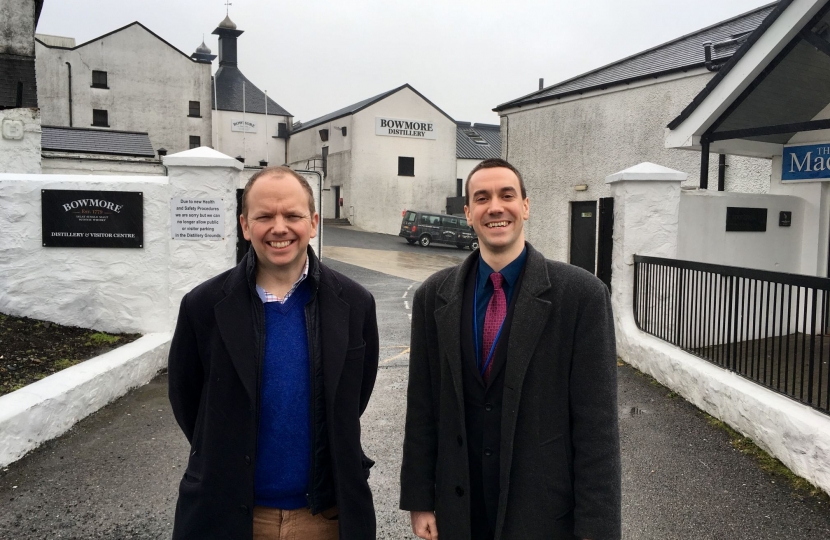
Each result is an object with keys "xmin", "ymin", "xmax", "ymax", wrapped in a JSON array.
[{"xmin": 213, "ymin": 259, "xmax": 259, "ymax": 403}]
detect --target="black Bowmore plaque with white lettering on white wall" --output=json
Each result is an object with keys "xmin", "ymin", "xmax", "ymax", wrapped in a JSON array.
[{"xmin": 40, "ymin": 189, "xmax": 144, "ymax": 248}]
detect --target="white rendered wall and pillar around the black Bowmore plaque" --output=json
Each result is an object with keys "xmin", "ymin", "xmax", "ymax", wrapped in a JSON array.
[{"xmin": 0, "ymin": 148, "xmax": 242, "ymax": 333}]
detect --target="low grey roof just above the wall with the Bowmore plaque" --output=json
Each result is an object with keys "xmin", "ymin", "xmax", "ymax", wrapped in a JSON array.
[{"xmin": 41, "ymin": 126, "xmax": 155, "ymax": 157}]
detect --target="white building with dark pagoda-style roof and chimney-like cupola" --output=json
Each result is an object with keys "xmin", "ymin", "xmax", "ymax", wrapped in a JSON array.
[{"xmin": 213, "ymin": 17, "xmax": 291, "ymax": 167}]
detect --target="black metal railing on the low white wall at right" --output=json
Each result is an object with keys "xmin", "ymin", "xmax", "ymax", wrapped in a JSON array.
[{"xmin": 633, "ymin": 255, "xmax": 830, "ymax": 414}]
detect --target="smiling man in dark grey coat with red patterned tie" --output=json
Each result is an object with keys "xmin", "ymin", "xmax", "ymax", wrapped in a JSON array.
[{"xmin": 400, "ymin": 159, "xmax": 621, "ymax": 540}]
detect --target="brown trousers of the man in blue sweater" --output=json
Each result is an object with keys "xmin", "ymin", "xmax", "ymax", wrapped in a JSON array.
[{"xmin": 254, "ymin": 506, "xmax": 340, "ymax": 540}]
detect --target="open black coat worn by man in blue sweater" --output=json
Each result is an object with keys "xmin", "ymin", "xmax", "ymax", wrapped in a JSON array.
[{"xmin": 168, "ymin": 250, "xmax": 378, "ymax": 540}]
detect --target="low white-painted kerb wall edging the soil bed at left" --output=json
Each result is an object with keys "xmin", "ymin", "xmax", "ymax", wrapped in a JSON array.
[{"xmin": 0, "ymin": 332, "xmax": 172, "ymax": 467}]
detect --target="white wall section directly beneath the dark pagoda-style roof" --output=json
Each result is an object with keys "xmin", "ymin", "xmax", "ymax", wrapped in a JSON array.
[{"xmin": 214, "ymin": 111, "xmax": 289, "ymax": 166}]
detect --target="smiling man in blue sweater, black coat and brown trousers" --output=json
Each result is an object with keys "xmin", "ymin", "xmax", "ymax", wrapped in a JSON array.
[{"xmin": 168, "ymin": 167, "xmax": 378, "ymax": 540}]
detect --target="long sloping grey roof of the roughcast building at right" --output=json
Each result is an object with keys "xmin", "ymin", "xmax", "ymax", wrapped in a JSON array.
[{"xmin": 494, "ymin": 2, "xmax": 777, "ymax": 111}]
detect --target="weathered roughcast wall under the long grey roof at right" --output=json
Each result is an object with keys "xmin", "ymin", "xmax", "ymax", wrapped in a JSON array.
[{"xmin": 501, "ymin": 69, "xmax": 770, "ymax": 262}]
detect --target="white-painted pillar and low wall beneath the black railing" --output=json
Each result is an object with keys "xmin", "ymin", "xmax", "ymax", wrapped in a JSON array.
[{"xmin": 611, "ymin": 168, "xmax": 830, "ymax": 493}]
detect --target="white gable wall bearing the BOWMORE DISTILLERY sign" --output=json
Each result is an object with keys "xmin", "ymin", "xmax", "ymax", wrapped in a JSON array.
[{"xmin": 350, "ymin": 88, "xmax": 456, "ymax": 234}]
